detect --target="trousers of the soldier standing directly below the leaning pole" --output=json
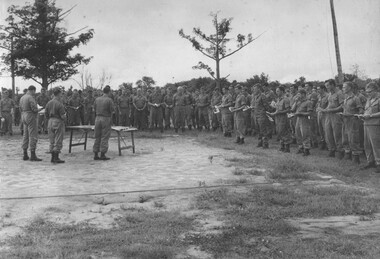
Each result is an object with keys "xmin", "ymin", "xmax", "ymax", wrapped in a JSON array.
[{"xmin": 325, "ymin": 113, "xmax": 343, "ymax": 151}]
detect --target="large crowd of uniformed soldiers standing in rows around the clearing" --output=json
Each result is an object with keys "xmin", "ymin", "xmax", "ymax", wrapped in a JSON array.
[{"xmin": 0, "ymin": 79, "xmax": 380, "ymax": 173}]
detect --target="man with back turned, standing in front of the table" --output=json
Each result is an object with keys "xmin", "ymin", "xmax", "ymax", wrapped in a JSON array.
[{"xmin": 93, "ymin": 85, "xmax": 115, "ymax": 160}]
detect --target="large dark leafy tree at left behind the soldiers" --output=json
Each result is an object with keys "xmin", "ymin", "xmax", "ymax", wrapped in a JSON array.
[{"xmin": 1, "ymin": 0, "xmax": 94, "ymax": 88}]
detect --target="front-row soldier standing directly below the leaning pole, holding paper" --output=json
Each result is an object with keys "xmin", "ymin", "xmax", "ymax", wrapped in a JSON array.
[{"xmin": 320, "ymin": 79, "xmax": 344, "ymax": 159}]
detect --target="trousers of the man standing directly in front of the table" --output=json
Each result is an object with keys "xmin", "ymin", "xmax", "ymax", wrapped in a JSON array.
[{"xmin": 93, "ymin": 116, "xmax": 112, "ymax": 153}]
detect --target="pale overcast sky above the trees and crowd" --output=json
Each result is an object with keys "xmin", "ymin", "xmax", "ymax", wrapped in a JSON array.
[{"xmin": 0, "ymin": 0, "xmax": 380, "ymax": 89}]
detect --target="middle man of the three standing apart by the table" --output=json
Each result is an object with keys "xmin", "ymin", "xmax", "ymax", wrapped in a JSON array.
[{"xmin": 45, "ymin": 88, "xmax": 66, "ymax": 163}]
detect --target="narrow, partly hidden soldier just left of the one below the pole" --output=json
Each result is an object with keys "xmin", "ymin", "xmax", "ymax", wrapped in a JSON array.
[{"xmin": 316, "ymin": 85, "xmax": 328, "ymax": 150}]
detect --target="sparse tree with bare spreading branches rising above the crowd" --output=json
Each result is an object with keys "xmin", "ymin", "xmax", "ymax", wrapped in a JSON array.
[{"xmin": 179, "ymin": 14, "xmax": 263, "ymax": 90}]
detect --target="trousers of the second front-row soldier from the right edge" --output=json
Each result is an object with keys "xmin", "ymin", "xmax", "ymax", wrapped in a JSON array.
[{"xmin": 342, "ymin": 116, "xmax": 362, "ymax": 155}]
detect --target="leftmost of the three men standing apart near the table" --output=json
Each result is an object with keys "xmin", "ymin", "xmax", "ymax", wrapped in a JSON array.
[{"xmin": 20, "ymin": 85, "xmax": 42, "ymax": 162}]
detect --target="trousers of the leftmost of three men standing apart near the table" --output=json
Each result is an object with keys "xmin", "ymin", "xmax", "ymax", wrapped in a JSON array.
[{"xmin": 21, "ymin": 112, "xmax": 38, "ymax": 151}]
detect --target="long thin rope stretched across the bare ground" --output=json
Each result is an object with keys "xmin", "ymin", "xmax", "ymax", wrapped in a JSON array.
[{"xmin": 0, "ymin": 183, "xmax": 273, "ymax": 201}]
